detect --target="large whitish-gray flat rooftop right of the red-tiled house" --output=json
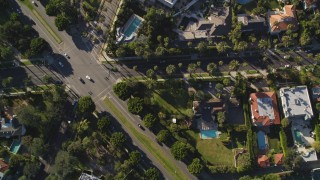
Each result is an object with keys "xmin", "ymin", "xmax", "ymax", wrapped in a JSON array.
[{"xmin": 280, "ymin": 86, "xmax": 313, "ymax": 120}]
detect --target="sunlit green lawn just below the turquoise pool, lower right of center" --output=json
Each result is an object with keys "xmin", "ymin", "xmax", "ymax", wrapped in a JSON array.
[{"xmin": 186, "ymin": 130, "xmax": 233, "ymax": 166}]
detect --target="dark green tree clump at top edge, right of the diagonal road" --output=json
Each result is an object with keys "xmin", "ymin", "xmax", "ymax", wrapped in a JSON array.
[{"xmin": 46, "ymin": 0, "xmax": 78, "ymax": 31}]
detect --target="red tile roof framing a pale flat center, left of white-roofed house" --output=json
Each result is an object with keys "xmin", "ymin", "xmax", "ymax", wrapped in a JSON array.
[{"xmin": 250, "ymin": 92, "xmax": 280, "ymax": 126}]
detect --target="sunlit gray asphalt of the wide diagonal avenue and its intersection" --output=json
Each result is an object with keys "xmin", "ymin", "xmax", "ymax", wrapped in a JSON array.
[{"xmin": 12, "ymin": 0, "xmax": 196, "ymax": 179}]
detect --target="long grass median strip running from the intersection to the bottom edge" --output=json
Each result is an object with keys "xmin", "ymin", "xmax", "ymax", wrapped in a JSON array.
[{"xmin": 104, "ymin": 98, "xmax": 188, "ymax": 179}]
